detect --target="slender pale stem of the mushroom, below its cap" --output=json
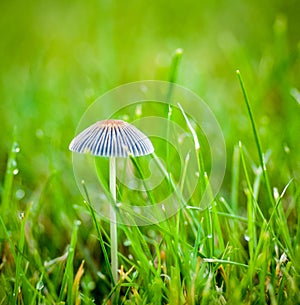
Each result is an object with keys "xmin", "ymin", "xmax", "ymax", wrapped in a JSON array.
[{"xmin": 109, "ymin": 157, "xmax": 118, "ymax": 283}]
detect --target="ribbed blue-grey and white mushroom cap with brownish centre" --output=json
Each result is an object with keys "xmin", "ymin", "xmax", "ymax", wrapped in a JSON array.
[{"xmin": 69, "ymin": 120, "xmax": 154, "ymax": 157}]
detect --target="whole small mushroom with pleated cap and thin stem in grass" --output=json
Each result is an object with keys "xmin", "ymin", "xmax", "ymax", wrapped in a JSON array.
[{"xmin": 69, "ymin": 120, "xmax": 154, "ymax": 283}]
